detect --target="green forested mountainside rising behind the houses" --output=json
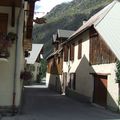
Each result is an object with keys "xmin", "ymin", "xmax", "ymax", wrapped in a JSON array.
[{"xmin": 33, "ymin": 0, "xmax": 113, "ymax": 57}]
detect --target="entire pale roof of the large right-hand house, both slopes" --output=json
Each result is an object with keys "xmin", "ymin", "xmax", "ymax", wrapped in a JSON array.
[{"xmin": 67, "ymin": 0, "xmax": 120, "ymax": 60}]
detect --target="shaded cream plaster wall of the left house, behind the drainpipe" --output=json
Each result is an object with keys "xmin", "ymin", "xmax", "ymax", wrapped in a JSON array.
[{"xmin": 0, "ymin": 7, "xmax": 24, "ymax": 106}]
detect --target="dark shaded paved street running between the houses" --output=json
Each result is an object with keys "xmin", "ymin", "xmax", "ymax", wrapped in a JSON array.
[{"xmin": 2, "ymin": 88, "xmax": 120, "ymax": 120}]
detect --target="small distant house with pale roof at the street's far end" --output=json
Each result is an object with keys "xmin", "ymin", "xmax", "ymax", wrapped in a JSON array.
[{"xmin": 25, "ymin": 44, "xmax": 43, "ymax": 82}]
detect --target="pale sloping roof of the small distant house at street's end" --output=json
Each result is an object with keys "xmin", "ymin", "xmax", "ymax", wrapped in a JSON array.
[{"xmin": 25, "ymin": 44, "xmax": 43, "ymax": 64}]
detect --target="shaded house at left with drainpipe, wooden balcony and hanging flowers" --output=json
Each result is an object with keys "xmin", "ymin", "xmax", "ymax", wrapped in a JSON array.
[{"xmin": 0, "ymin": 0, "xmax": 35, "ymax": 113}]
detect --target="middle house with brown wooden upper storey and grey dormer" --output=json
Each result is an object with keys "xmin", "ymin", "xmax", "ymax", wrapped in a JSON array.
[{"xmin": 46, "ymin": 29, "xmax": 74, "ymax": 93}]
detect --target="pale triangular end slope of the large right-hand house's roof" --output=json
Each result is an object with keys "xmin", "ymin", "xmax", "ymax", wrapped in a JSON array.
[{"xmin": 94, "ymin": 1, "xmax": 120, "ymax": 60}]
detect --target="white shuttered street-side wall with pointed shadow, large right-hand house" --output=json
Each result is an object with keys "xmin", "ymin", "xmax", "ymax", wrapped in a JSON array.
[{"xmin": 63, "ymin": 31, "xmax": 94, "ymax": 101}]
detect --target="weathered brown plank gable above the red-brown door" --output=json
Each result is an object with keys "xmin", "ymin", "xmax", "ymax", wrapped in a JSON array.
[{"xmin": 90, "ymin": 28, "xmax": 116, "ymax": 64}]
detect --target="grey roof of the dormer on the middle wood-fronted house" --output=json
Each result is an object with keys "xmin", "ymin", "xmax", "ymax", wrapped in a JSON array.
[{"xmin": 57, "ymin": 29, "xmax": 75, "ymax": 38}]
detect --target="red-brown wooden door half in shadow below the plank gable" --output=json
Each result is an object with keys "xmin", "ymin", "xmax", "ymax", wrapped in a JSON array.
[{"xmin": 93, "ymin": 75, "xmax": 107, "ymax": 106}]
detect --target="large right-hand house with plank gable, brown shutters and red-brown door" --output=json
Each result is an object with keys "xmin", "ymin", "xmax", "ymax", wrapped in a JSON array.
[{"xmin": 63, "ymin": 1, "xmax": 120, "ymax": 111}]
